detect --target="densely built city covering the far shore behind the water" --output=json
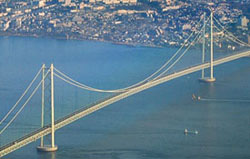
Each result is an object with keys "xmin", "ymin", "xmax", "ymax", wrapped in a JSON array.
[{"xmin": 0, "ymin": 0, "xmax": 249, "ymax": 47}]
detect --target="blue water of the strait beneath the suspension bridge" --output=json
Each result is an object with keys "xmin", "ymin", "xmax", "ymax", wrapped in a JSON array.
[{"xmin": 0, "ymin": 37, "xmax": 250, "ymax": 159}]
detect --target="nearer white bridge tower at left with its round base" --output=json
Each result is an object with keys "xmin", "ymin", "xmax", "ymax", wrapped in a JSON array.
[{"xmin": 37, "ymin": 64, "xmax": 58, "ymax": 152}]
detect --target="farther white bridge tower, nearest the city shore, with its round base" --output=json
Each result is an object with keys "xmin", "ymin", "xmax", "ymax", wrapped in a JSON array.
[{"xmin": 200, "ymin": 11, "xmax": 216, "ymax": 83}]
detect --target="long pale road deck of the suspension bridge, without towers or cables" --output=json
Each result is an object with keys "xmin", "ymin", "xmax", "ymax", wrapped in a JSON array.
[{"xmin": 0, "ymin": 50, "xmax": 250, "ymax": 157}]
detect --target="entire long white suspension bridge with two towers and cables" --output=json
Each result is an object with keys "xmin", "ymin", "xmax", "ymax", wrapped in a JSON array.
[{"xmin": 0, "ymin": 13, "xmax": 250, "ymax": 157}]
